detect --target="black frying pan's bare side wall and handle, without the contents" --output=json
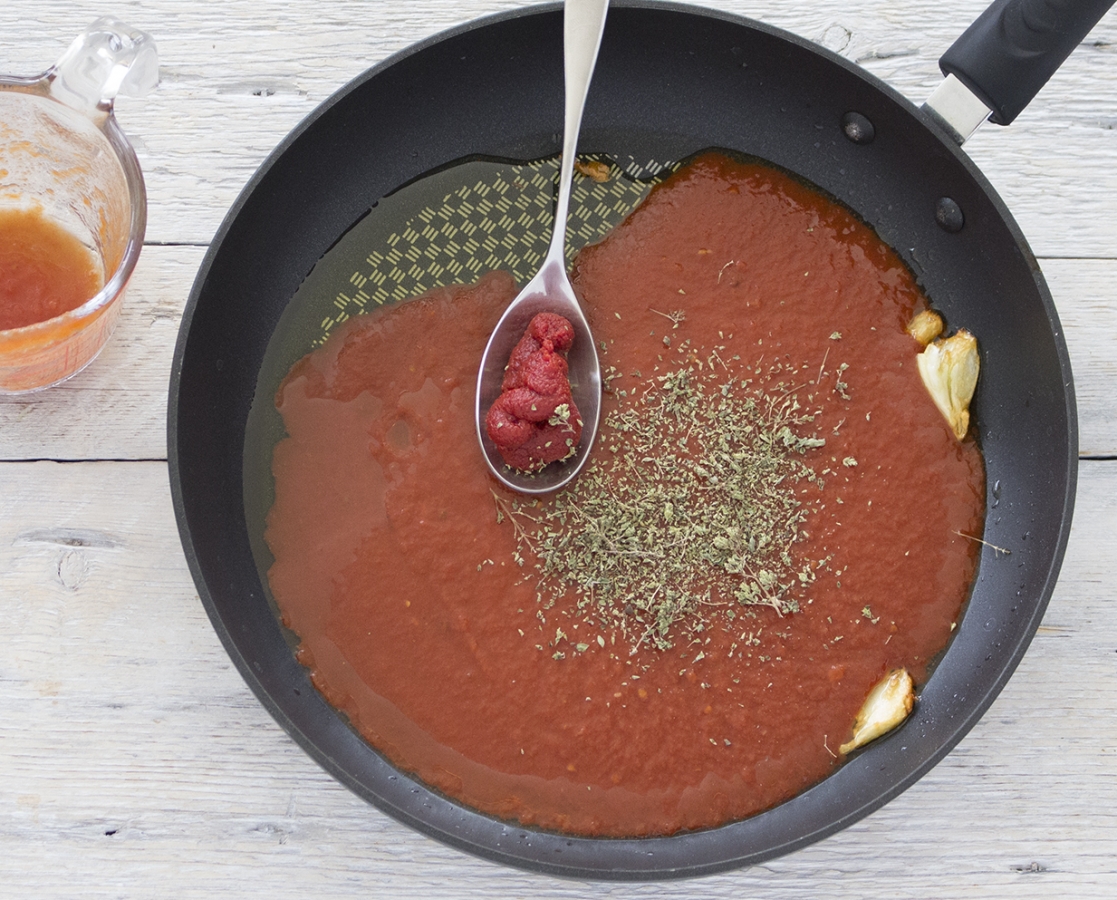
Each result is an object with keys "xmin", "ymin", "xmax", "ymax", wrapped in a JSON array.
[{"xmin": 169, "ymin": 0, "xmax": 1111, "ymax": 879}]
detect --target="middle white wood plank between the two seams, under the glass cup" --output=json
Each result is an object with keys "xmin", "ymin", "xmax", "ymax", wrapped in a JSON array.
[{"xmin": 0, "ymin": 253, "xmax": 1117, "ymax": 460}]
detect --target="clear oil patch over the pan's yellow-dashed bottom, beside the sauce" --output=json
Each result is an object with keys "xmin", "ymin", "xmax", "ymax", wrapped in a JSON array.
[{"xmin": 244, "ymin": 154, "xmax": 681, "ymax": 607}]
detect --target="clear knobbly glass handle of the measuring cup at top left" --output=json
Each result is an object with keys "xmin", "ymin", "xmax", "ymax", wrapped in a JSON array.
[{"xmin": 46, "ymin": 16, "xmax": 159, "ymax": 114}]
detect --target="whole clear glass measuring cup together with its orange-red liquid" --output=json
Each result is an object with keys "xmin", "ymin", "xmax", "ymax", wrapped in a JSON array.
[{"xmin": 0, "ymin": 18, "xmax": 159, "ymax": 393}]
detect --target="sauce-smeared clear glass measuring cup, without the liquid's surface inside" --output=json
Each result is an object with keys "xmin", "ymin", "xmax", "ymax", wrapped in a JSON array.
[{"xmin": 0, "ymin": 17, "xmax": 159, "ymax": 393}]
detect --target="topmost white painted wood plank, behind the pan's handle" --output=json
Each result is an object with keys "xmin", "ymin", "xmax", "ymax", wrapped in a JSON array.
[{"xmin": 0, "ymin": 0, "xmax": 1117, "ymax": 257}]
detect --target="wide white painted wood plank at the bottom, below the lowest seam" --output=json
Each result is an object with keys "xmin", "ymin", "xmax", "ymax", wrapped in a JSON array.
[{"xmin": 0, "ymin": 462, "xmax": 1117, "ymax": 900}]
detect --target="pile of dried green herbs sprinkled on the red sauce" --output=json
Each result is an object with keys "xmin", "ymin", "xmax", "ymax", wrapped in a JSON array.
[{"xmin": 499, "ymin": 355, "xmax": 825, "ymax": 652}]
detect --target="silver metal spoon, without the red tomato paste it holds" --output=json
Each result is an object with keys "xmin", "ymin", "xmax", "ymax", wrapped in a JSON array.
[{"xmin": 475, "ymin": 0, "xmax": 609, "ymax": 494}]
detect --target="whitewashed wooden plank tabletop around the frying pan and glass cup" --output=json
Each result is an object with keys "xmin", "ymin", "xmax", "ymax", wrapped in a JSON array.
[{"xmin": 0, "ymin": 0, "xmax": 1117, "ymax": 900}]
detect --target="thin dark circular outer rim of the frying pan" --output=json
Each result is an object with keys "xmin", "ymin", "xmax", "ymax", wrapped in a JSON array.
[{"xmin": 168, "ymin": 0, "xmax": 1078, "ymax": 881}]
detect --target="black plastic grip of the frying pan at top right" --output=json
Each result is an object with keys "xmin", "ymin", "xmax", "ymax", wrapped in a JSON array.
[{"xmin": 938, "ymin": 0, "xmax": 1115, "ymax": 125}]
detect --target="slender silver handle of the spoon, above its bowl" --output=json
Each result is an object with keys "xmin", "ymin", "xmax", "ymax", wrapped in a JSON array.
[{"xmin": 547, "ymin": 0, "xmax": 609, "ymax": 265}]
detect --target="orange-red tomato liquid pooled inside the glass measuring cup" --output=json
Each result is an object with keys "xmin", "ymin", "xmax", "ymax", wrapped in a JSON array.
[{"xmin": 0, "ymin": 210, "xmax": 103, "ymax": 331}]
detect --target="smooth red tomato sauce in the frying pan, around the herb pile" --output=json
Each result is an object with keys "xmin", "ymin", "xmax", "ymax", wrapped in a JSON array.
[{"xmin": 266, "ymin": 155, "xmax": 984, "ymax": 836}]
